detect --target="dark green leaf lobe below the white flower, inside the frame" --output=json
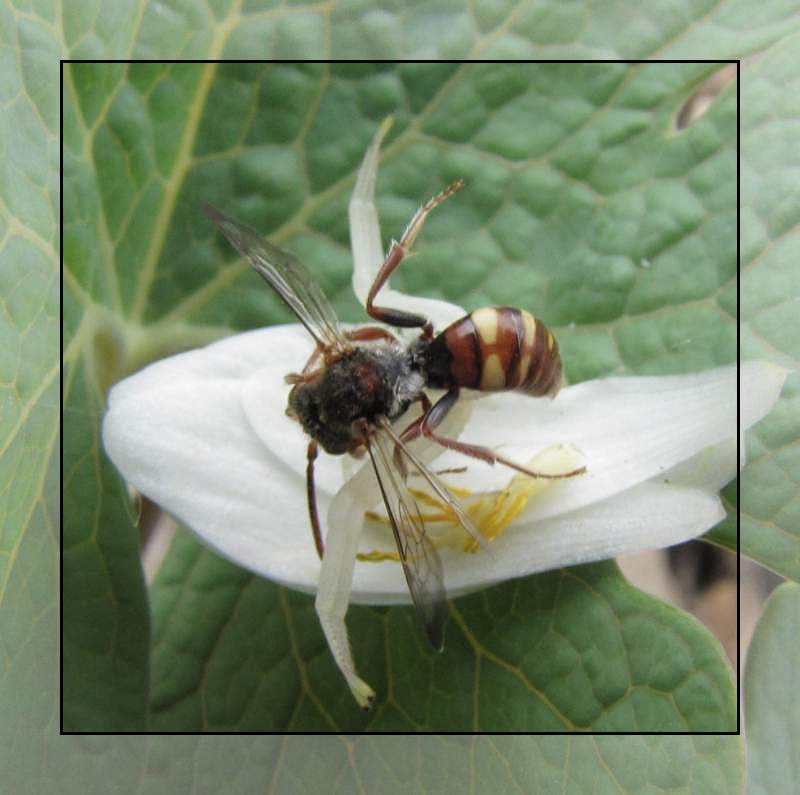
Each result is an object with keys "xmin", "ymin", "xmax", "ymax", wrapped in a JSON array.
[{"xmin": 151, "ymin": 534, "xmax": 736, "ymax": 732}]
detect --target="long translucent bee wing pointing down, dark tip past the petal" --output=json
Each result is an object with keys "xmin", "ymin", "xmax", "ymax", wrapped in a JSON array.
[{"xmin": 367, "ymin": 426, "xmax": 447, "ymax": 650}]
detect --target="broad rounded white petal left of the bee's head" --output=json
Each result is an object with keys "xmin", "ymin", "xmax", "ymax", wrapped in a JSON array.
[{"xmin": 103, "ymin": 327, "xmax": 319, "ymax": 587}]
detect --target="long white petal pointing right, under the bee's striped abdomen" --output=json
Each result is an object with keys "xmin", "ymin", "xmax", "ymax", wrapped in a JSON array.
[{"xmin": 424, "ymin": 362, "xmax": 786, "ymax": 520}]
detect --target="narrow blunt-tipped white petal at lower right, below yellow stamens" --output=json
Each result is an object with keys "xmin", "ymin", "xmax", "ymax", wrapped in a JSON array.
[{"xmin": 352, "ymin": 483, "xmax": 725, "ymax": 604}]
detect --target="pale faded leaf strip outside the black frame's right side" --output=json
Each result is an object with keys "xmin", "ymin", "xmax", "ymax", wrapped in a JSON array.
[{"xmin": 711, "ymin": 35, "xmax": 800, "ymax": 581}]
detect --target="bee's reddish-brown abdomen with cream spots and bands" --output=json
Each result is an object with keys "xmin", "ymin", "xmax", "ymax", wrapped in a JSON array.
[{"xmin": 427, "ymin": 306, "xmax": 561, "ymax": 397}]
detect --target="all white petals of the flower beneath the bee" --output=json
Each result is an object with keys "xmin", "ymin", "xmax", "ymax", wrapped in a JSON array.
[{"xmin": 103, "ymin": 326, "xmax": 785, "ymax": 603}]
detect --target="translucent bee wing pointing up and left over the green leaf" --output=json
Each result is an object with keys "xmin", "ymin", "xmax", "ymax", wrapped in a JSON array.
[{"xmin": 204, "ymin": 205, "xmax": 350, "ymax": 350}]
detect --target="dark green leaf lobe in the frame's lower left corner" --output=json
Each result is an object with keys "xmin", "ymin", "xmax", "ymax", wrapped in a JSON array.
[{"xmin": 62, "ymin": 360, "xmax": 149, "ymax": 731}]
